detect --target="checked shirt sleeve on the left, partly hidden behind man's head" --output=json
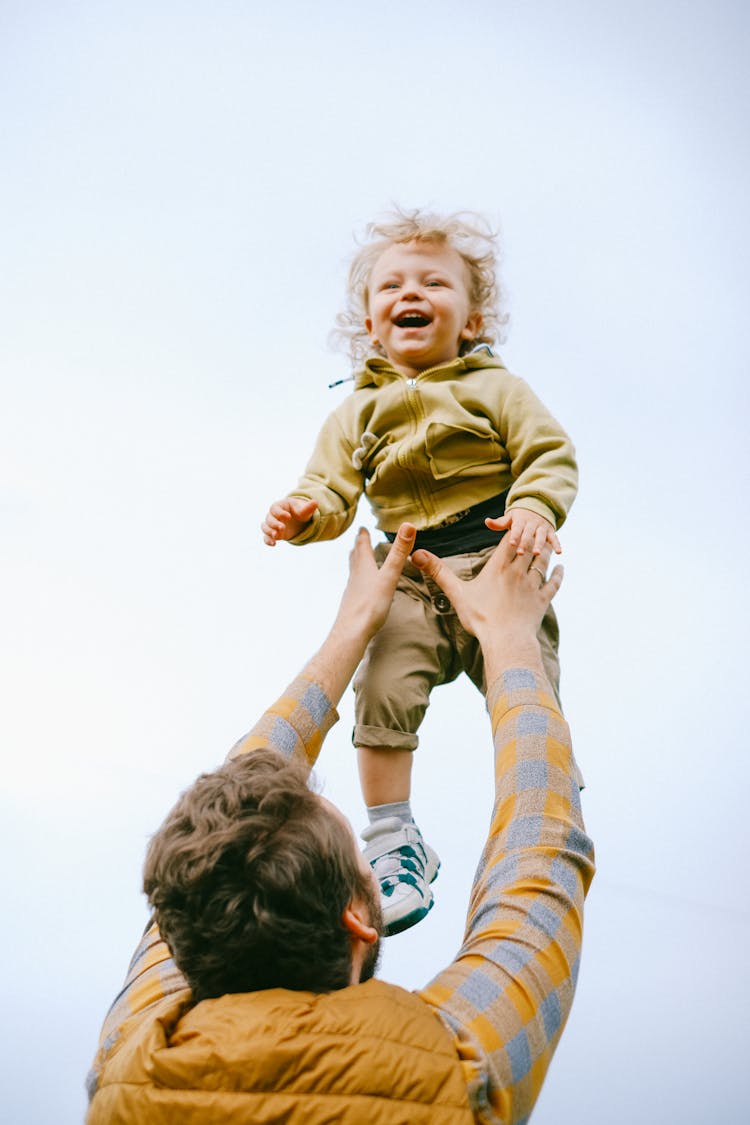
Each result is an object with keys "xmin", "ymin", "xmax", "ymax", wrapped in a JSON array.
[{"xmin": 85, "ymin": 676, "xmax": 338, "ymax": 1098}]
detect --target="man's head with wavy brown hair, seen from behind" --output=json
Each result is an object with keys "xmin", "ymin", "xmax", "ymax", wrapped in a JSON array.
[{"xmin": 144, "ymin": 749, "xmax": 381, "ymax": 1000}]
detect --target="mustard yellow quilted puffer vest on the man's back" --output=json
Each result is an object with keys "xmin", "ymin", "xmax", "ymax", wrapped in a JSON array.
[{"xmin": 88, "ymin": 980, "xmax": 473, "ymax": 1125}]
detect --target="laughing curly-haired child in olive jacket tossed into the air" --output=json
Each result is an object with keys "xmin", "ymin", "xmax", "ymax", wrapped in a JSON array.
[{"xmin": 262, "ymin": 210, "xmax": 578, "ymax": 934}]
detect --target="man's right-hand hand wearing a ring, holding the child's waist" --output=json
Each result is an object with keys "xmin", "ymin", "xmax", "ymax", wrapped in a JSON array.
[{"xmin": 412, "ymin": 536, "xmax": 562, "ymax": 684}]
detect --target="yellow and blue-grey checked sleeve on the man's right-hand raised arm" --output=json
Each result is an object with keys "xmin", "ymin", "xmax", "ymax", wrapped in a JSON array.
[{"xmin": 419, "ymin": 669, "xmax": 594, "ymax": 1125}]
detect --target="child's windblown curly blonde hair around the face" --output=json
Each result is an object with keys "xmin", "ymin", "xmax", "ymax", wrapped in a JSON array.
[{"xmin": 331, "ymin": 208, "xmax": 508, "ymax": 366}]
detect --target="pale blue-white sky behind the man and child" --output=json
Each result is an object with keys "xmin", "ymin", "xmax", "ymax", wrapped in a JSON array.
[{"xmin": 0, "ymin": 0, "xmax": 750, "ymax": 1125}]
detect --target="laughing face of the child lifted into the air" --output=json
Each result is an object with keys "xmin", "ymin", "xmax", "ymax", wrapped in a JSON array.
[{"xmin": 364, "ymin": 242, "xmax": 481, "ymax": 376}]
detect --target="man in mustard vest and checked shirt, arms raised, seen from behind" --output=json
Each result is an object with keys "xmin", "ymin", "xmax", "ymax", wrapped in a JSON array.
[{"xmin": 88, "ymin": 524, "xmax": 594, "ymax": 1125}]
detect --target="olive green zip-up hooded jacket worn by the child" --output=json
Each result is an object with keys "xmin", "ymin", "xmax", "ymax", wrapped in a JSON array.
[{"xmin": 290, "ymin": 353, "xmax": 578, "ymax": 543}]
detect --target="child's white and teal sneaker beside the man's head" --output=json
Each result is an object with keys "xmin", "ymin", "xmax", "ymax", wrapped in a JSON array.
[{"xmin": 361, "ymin": 817, "xmax": 440, "ymax": 936}]
